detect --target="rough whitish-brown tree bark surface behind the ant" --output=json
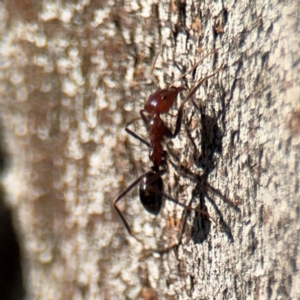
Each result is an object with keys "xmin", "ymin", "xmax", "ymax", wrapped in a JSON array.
[{"xmin": 0, "ymin": 0, "xmax": 300, "ymax": 300}]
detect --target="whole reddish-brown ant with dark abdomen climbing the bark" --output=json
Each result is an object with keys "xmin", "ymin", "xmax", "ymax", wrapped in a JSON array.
[{"xmin": 113, "ymin": 50, "xmax": 223, "ymax": 237}]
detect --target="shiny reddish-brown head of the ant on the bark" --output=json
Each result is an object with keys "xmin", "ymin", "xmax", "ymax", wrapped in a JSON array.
[{"xmin": 144, "ymin": 86, "xmax": 184, "ymax": 114}]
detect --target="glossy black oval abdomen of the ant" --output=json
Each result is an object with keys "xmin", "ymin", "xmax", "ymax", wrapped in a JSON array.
[{"xmin": 140, "ymin": 171, "xmax": 163, "ymax": 215}]
